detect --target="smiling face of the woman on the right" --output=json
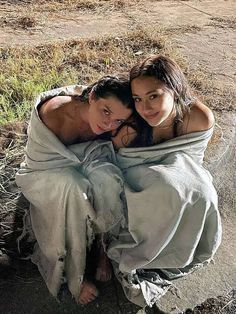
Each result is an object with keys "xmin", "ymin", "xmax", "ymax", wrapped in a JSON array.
[{"xmin": 131, "ymin": 76, "xmax": 174, "ymax": 127}]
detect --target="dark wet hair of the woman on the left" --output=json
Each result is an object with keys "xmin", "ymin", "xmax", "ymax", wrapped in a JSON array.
[{"xmin": 80, "ymin": 75, "xmax": 134, "ymax": 110}]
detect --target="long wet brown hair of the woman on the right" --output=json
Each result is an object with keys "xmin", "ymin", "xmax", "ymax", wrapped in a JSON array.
[{"xmin": 130, "ymin": 55, "xmax": 195, "ymax": 146}]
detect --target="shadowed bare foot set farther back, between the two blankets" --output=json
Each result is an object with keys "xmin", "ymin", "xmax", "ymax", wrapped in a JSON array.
[{"xmin": 95, "ymin": 245, "xmax": 112, "ymax": 281}]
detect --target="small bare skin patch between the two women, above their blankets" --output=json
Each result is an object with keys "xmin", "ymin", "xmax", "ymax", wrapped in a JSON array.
[{"xmin": 112, "ymin": 125, "xmax": 137, "ymax": 148}]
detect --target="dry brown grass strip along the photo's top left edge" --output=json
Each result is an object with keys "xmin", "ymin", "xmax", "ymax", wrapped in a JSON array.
[{"xmin": 0, "ymin": 0, "xmax": 141, "ymax": 32}]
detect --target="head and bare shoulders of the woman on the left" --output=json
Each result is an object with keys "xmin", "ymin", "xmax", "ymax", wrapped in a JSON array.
[{"xmin": 38, "ymin": 76, "xmax": 133, "ymax": 145}]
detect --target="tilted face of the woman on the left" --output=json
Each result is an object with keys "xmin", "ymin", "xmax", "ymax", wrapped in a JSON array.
[{"xmin": 89, "ymin": 95, "xmax": 132, "ymax": 135}]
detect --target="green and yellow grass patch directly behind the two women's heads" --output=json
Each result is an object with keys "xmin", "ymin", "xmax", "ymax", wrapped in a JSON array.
[{"xmin": 0, "ymin": 30, "xmax": 169, "ymax": 124}]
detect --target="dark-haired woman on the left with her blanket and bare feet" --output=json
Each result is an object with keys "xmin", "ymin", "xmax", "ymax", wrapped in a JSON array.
[{"xmin": 16, "ymin": 76, "xmax": 134, "ymax": 304}]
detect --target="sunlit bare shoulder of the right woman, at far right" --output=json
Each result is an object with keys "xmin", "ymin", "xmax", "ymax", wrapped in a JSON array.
[{"xmin": 184, "ymin": 101, "xmax": 215, "ymax": 133}]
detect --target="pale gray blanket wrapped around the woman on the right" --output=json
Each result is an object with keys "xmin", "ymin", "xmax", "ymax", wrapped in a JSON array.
[{"xmin": 108, "ymin": 128, "xmax": 221, "ymax": 305}]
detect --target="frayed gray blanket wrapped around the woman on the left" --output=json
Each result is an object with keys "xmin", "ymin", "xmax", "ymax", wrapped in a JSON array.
[{"xmin": 16, "ymin": 86, "xmax": 126, "ymax": 297}]
